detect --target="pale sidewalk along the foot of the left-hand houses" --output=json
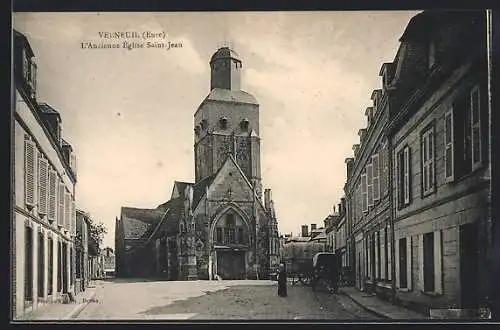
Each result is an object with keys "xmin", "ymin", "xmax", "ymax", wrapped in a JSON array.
[{"xmin": 25, "ymin": 283, "xmax": 99, "ymax": 321}]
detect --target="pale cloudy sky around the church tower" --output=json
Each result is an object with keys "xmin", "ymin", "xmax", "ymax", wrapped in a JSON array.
[{"xmin": 13, "ymin": 11, "xmax": 418, "ymax": 247}]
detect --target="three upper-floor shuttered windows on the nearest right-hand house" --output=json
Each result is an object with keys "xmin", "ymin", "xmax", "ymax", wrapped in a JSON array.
[{"xmin": 396, "ymin": 86, "xmax": 482, "ymax": 207}]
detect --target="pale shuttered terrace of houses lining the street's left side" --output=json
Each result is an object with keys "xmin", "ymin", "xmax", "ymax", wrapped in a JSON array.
[{"xmin": 11, "ymin": 31, "xmax": 76, "ymax": 318}]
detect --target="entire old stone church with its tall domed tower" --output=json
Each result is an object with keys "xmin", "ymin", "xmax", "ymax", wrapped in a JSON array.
[{"xmin": 115, "ymin": 47, "xmax": 279, "ymax": 280}]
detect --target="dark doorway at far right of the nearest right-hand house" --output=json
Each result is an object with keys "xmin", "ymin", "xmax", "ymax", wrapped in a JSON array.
[{"xmin": 460, "ymin": 223, "xmax": 479, "ymax": 308}]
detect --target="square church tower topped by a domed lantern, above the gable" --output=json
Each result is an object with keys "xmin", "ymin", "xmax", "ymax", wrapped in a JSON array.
[{"xmin": 194, "ymin": 47, "xmax": 262, "ymax": 196}]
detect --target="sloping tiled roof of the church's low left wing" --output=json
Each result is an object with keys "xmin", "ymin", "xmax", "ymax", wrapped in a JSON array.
[{"xmin": 121, "ymin": 207, "xmax": 165, "ymax": 239}]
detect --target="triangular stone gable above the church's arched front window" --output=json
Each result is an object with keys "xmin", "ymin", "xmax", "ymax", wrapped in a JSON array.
[{"xmin": 208, "ymin": 156, "xmax": 254, "ymax": 201}]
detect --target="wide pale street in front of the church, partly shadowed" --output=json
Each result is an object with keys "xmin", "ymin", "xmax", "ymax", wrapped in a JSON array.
[{"xmin": 77, "ymin": 279, "xmax": 377, "ymax": 320}]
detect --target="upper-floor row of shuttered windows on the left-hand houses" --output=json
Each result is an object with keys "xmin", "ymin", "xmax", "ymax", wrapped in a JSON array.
[{"xmin": 24, "ymin": 139, "xmax": 76, "ymax": 235}]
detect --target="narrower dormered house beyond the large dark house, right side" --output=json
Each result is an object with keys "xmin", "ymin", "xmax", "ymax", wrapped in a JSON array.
[{"xmin": 344, "ymin": 76, "xmax": 392, "ymax": 295}]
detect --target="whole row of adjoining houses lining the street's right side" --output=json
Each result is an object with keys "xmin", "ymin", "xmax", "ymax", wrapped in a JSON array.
[{"xmin": 336, "ymin": 11, "xmax": 492, "ymax": 313}]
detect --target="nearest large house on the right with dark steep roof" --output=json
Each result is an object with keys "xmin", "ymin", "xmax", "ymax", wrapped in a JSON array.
[{"xmin": 389, "ymin": 12, "xmax": 491, "ymax": 309}]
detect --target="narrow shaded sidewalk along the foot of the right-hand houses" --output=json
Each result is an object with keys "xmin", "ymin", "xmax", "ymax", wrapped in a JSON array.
[{"xmin": 339, "ymin": 287, "xmax": 429, "ymax": 320}]
